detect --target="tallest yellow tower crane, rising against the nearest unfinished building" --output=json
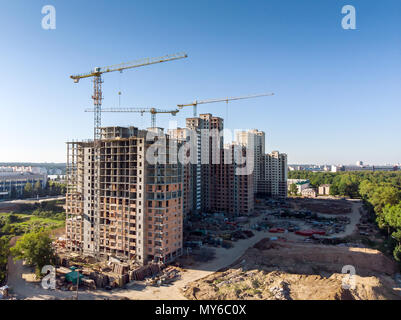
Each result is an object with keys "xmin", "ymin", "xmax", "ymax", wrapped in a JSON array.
[{"xmin": 70, "ymin": 53, "xmax": 188, "ymax": 258}]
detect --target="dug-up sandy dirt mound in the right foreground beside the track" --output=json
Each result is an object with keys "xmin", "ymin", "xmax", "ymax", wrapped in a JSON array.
[{"xmin": 183, "ymin": 239, "xmax": 401, "ymax": 300}]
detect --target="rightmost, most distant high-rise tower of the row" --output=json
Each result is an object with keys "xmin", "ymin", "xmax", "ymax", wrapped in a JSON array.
[{"xmin": 259, "ymin": 151, "xmax": 288, "ymax": 198}]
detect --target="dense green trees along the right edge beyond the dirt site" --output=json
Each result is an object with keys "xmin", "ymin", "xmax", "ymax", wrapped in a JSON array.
[{"xmin": 289, "ymin": 171, "xmax": 401, "ymax": 262}]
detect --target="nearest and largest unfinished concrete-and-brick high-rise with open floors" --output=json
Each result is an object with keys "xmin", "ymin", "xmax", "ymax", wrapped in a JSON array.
[{"xmin": 66, "ymin": 127, "xmax": 183, "ymax": 265}]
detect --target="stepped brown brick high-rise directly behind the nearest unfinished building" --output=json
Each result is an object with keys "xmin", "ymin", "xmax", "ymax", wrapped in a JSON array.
[{"xmin": 177, "ymin": 113, "xmax": 254, "ymax": 215}]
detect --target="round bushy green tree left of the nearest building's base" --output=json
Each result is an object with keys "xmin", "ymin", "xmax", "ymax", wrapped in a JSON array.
[{"xmin": 11, "ymin": 231, "xmax": 55, "ymax": 276}]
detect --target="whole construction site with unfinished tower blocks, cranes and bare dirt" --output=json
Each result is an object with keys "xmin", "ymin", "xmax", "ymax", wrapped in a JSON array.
[{"xmin": 3, "ymin": 54, "xmax": 401, "ymax": 300}]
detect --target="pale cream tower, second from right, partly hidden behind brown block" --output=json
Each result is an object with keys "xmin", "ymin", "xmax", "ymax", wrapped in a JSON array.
[{"xmin": 236, "ymin": 129, "xmax": 266, "ymax": 193}]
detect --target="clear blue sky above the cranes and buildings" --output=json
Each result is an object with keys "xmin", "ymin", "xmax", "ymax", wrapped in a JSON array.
[{"xmin": 0, "ymin": 0, "xmax": 401, "ymax": 164}]
